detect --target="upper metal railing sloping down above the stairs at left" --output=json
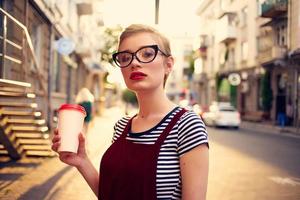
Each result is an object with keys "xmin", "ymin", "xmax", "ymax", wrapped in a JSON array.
[{"xmin": 0, "ymin": 8, "xmax": 47, "ymax": 94}]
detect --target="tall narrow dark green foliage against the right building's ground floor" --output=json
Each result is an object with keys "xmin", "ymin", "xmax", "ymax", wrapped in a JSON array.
[{"xmin": 260, "ymin": 71, "xmax": 273, "ymax": 112}]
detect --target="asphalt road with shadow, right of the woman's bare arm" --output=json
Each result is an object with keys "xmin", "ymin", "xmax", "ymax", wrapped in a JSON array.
[{"xmin": 207, "ymin": 128, "xmax": 300, "ymax": 200}]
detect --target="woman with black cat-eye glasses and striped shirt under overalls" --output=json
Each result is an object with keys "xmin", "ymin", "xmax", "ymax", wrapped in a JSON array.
[{"xmin": 52, "ymin": 25, "xmax": 208, "ymax": 200}]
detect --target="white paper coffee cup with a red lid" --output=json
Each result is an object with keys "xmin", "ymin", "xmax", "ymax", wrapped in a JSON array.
[{"xmin": 58, "ymin": 104, "xmax": 86, "ymax": 153}]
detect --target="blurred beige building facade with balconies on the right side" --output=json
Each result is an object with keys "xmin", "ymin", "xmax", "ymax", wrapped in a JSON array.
[{"xmin": 198, "ymin": 0, "xmax": 299, "ymax": 126}]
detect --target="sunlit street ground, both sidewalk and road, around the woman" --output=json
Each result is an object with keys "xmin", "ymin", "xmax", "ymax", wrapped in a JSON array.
[{"xmin": 0, "ymin": 107, "xmax": 300, "ymax": 200}]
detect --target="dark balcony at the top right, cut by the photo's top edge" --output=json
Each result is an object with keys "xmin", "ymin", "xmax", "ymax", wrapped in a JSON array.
[{"xmin": 261, "ymin": 0, "xmax": 288, "ymax": 18}]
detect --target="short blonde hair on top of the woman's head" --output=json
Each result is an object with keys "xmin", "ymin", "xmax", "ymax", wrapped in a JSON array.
[{"xmin": 119, "ymin": 24, "xmax": 171, "ymax": 55}]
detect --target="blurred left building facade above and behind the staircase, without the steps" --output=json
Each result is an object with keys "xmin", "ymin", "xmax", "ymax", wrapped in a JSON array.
[{"xmin": 0, "ymin": 0, "xmax": 105, "ymax": 128}]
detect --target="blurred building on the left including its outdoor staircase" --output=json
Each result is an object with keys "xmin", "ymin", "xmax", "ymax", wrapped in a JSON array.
[{"xmin": 0, "ymin": 0, "xmax": 106, "ymax": 158}]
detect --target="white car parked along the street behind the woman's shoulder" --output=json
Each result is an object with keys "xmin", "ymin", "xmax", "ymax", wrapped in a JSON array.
[{"xmin": 202, "ymin": 102, "xmax": 241, "ymax": 129}]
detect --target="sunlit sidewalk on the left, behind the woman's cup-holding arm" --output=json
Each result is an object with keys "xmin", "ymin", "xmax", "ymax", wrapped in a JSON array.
[{"xmin": 0, "ymin": 107, "xmax": 123, "ymax": 200}]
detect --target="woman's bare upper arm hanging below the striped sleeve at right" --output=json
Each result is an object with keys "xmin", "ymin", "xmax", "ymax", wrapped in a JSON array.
[{"xmin": 180, "ymin": 144, "xmax": 208, "ymax": 200}]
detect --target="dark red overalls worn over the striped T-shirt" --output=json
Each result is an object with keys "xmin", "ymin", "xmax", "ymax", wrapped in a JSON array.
[{"xmin": 98, "ymin": 109, "xmax": 186, "ymax": 200}]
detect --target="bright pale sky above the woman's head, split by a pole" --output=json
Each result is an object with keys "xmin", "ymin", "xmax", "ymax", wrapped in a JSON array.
[{"xmin": 103, "ymin": 0, "xmax": 201, "ymax": 35}]
